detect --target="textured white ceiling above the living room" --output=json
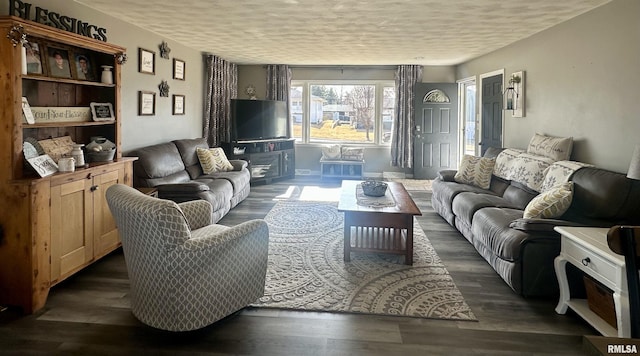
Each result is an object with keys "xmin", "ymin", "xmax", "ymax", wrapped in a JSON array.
[{"xmin": 76, "ymin": 0, "xmax": 610, "ymax": 65}]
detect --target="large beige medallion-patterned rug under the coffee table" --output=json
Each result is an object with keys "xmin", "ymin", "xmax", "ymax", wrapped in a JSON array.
[{"xmin": 253, "ymin": 201, "xmax": 476, "ymax": 320}]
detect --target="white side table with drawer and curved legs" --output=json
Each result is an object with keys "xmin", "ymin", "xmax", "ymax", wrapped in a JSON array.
[{"xmin": 555, "ymin": 227, "xmax": 631, "ymax": 338}]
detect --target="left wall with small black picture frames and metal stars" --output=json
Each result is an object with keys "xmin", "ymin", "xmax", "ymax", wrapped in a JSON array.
[{"xmin": 0, "ymin": 0, "xmax": 204, "ymax": 154}]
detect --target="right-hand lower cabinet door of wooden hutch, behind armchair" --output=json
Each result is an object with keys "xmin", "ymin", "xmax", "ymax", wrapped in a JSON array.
[{"xmin": 92, "ymin": 168, "xmax": 124, "ymax": 258}]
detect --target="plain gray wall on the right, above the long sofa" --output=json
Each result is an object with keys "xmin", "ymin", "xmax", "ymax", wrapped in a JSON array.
[{"xmin": 457, "ymin": 0, "xmax": 640, "ymax": 172}]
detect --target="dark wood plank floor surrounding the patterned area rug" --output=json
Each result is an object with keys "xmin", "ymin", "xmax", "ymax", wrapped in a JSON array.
[{"xmin": 0, "ymin": 177, "xmax": 598, "ymax": 355}]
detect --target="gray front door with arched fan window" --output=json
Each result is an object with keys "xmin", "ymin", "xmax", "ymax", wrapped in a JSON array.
[{"xmin": 413, "ymin": 83, "xmax": 458, "ymax": 179}]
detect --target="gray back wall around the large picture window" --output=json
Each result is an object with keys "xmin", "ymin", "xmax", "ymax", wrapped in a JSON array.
[{"xmin": 238, "ymin": 65, "xmax": 455, "ymax": 177}]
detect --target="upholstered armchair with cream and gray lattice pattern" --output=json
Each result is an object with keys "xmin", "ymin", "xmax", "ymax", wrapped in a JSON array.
[{"xmin": 106, "ymin": 184, "xmax": 269, "ymax": 331}]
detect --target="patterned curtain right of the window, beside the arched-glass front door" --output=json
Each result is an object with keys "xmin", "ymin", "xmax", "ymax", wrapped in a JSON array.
[{"xmin": 391, "ymin": 65, "xmax": 422, "ymax": 168}]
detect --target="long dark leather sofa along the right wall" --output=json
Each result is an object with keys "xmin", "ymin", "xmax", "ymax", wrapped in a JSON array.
[{"xmin": 431, "ymin": 160, "xmax": 640, "ymax": 296}]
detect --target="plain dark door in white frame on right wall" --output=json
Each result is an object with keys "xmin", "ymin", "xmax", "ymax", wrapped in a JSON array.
[{"xmin": 480, "ymin": 74, "xmax": 502, "ymax": 155}]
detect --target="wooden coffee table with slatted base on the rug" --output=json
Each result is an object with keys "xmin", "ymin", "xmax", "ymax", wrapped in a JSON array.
[{"xmin": 338, "ymin": 180, "xmax": 422, "ymax": 265}]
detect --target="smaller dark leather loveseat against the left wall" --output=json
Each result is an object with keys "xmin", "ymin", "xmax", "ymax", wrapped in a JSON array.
[{"xmin": 128, "ymin": 138, "xmax": 251, "ymax": 222}]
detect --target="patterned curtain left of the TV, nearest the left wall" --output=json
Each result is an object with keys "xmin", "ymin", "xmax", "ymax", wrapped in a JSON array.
[{"xmin": 203, "ymin": 55, "xmax": 238, "ymax": 147}]
